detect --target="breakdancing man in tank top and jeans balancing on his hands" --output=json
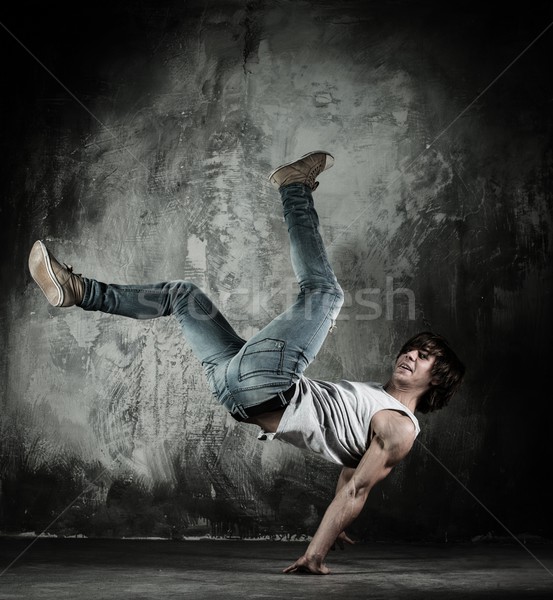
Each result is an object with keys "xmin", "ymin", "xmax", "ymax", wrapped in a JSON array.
[{"xmin": 29, "ymin": 151, "xmax": 464, "ymax": 574}]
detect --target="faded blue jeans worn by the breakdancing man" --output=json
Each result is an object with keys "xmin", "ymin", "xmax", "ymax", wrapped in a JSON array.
[{"xmin": 80, "ymin": 184, "xmax": 344, "ymax": 420}]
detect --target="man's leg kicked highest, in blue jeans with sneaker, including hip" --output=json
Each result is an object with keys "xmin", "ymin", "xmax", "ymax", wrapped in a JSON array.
[{"xmin": 223, "ymin": 153, "xmax": 343, "ymax": 418}]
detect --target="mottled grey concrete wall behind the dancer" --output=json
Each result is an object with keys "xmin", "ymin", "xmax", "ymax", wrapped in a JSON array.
[{"xmin": 0, "ymin": 0, "xmax": 553, "ymax": 539}]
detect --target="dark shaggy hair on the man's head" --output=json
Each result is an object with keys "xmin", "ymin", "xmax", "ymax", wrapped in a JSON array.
[{"xmin": 398, "ymin": 331, "xmax": 465, "ymax": 413}]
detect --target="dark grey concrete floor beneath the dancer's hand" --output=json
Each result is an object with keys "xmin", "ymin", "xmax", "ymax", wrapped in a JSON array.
[{"xmin": 0, "ymin": 538, "xmax": 553, "ymax": 600}]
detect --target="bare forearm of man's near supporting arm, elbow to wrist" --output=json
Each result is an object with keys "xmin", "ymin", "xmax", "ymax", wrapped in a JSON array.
[{"xmin": 305, "ymin": 487, "xmax": 366, "ymax": 560}]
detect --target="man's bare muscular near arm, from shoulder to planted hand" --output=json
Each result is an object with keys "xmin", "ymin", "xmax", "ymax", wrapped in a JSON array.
[{"xmin": 284, "ymin": 410, "xmax": 415, "ymax": 575}]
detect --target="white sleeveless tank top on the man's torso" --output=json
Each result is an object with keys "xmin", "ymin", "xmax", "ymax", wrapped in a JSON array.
[{"xmin": 258, "ymin": 377, "xmax": 420, "ymax": 467}]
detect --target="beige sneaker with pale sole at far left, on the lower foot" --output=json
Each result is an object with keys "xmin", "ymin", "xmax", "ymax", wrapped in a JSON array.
[{"xmin": 29, "ymin": 240, "xmax": 84, "ymax": 306}]
